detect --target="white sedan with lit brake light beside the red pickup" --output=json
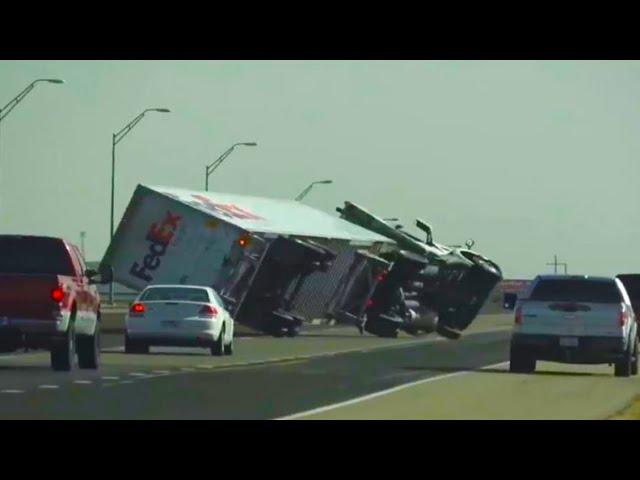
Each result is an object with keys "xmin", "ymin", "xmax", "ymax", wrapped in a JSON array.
[{"xmin": 124, "ymin": 285, "xmax": 234, "ymax": 355}]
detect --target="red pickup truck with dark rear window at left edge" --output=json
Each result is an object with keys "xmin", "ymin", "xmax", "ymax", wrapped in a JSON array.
[{"xmin": 0, "ymin": 235, "xmax": 111, "ymax": 371}]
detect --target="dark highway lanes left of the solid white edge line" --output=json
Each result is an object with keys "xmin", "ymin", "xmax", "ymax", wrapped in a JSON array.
[{"xmin": 0, "ymin": 316, "xmax": 509, "ymax": 419}]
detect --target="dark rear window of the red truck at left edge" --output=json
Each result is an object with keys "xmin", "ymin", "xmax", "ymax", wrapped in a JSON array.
[{"xmin": 0, "ymin": 236, "xmax": 75, "ymax": 276}]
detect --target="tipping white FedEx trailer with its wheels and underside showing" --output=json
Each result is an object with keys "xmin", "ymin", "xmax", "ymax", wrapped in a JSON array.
[{"xmin": 101, "ymin": 185, "xmax": 395, "ymax": 336}]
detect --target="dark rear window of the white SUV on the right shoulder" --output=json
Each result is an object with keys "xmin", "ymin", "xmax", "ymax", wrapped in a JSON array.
[{"xmin": 529, "ymin": 280, "xmax": 622, "ymax": 303}]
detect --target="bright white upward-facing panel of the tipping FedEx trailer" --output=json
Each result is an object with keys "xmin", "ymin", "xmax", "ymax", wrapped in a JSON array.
[{"xmin": 140, "ymin": 185, "xmax": 394, "ymax": 243}]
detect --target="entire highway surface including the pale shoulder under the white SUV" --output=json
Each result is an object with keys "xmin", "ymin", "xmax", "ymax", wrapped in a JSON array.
[{"xmin": 0, "ymin": 315, "xmax": 640, "ymax": 419}]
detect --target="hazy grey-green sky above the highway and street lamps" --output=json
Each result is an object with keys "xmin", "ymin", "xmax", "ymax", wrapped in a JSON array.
[{"xmin": 0, "ymin": 61, "xmax": 640, "ymax": 277}]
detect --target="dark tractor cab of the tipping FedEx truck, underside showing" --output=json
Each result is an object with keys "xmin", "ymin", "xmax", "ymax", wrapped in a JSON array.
[{"xmin": 337, "ymin": 202, "xmax": 502, "ymax": 339}]
